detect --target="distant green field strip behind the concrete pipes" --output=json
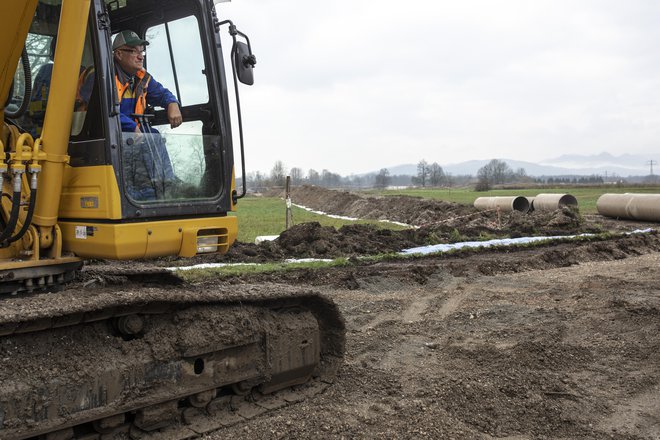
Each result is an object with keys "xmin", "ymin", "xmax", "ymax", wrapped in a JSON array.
[{"xmin": 365, "ymin": 185, "xmax": 660, "ymax": 214}]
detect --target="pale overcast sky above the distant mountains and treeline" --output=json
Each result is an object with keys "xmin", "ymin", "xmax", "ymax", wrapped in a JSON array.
[{"xmin": 218, "ymin": 0, "xmax": 660, "ymax": 175}]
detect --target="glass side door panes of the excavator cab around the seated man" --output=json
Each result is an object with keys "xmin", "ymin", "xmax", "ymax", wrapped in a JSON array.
[{"xmin": 107, "ymin": 0, "xmax": 224, "ymax": 205}]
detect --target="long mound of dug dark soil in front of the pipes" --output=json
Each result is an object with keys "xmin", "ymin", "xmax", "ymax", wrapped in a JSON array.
[{"xmin": 152, "ymin": 186, "xmax": 657, "ymax": 265}]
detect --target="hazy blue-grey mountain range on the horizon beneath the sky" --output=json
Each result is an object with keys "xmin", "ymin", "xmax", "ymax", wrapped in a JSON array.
[{"xmin": 388, "ymin": 152, "xmax": 660, "ymax": 177}]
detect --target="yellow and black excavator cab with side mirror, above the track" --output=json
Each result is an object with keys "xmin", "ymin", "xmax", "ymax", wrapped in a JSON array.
[{"xmin": 0, "ymin": 0, "xmax": 256, "ymax": 290}]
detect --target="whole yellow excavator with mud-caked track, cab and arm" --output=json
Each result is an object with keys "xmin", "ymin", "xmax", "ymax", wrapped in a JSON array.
[{"xmin": 0, "ymin": 0, "xmax": 345, "ymax": 440}]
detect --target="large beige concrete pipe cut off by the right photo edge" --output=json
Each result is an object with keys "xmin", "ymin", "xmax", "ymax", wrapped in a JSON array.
[{"xmin": 596, "ymin": 193, "xmax": 660, "ymax": 222}]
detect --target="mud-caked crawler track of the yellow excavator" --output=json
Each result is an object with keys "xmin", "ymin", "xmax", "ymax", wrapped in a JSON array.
[{"xmin": 0, "ymin": 283, "xmax": 345, "ymax": 440}]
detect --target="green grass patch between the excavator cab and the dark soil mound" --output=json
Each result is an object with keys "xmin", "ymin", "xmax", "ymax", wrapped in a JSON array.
[{"xmin": 231, "ymin": 197, "xmax": 404, "ymax": 243}]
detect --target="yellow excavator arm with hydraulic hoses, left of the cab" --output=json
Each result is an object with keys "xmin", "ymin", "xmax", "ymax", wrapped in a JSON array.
[{"xmin": 0, "ymin": 0, "xmax": 90, "ymax": 291}]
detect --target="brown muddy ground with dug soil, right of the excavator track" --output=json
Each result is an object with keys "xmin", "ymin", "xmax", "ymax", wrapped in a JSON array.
[{"xmin": 60, "ymin": 190, "xmax": 660, "ymax": 440}]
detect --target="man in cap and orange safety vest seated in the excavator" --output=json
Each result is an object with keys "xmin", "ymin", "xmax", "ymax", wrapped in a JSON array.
[{"xmin": 112, "ymin": 30, "xmax": 183, "ymax": 200}]
